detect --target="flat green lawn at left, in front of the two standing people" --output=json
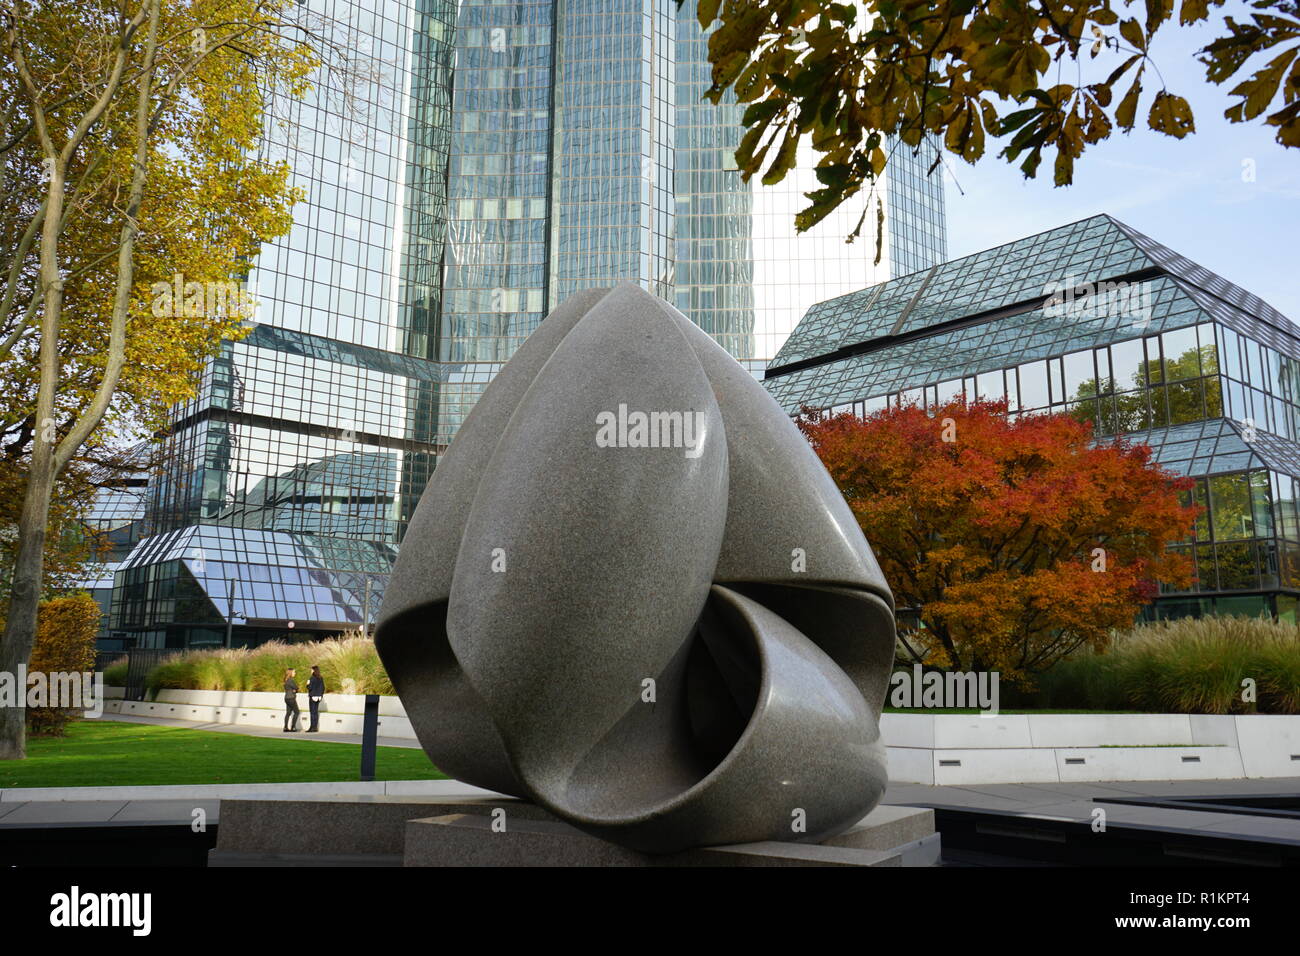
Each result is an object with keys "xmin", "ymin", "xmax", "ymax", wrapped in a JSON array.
[{"xmin": 0, "ymin": 721, "xmax": 446, "ymax": 788}]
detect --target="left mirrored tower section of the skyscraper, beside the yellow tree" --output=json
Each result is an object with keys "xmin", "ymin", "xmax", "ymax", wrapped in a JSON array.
[{"xmin": 112, "ymin": 0, "xmax": 454, "ymax": 646}]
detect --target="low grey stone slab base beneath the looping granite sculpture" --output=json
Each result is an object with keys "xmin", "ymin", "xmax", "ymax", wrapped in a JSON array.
[{"xmin": 208, "ymin": 791, "xmax": 940, "ymax": 866}]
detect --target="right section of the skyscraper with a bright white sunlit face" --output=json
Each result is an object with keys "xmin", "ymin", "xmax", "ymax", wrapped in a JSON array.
[{"xmin": 671, "ymin": 0, "xmax": 948, "ymax": 375}]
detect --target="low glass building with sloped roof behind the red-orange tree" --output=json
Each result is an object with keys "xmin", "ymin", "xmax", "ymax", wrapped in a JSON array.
[{"xmin": 764, "ymin": 216, "xmax": 1300, "ymax": 620}]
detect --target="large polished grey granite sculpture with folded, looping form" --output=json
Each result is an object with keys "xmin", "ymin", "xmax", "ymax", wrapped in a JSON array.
[{"xmin": 376, "ymin": 284, "xmax": 894, "ymax": 853}]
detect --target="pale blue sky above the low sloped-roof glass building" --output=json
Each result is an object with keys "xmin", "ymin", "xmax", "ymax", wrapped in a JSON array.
[{"xmin": 945, "ymin": 10, "xmax": 1300, "ymax": 324}]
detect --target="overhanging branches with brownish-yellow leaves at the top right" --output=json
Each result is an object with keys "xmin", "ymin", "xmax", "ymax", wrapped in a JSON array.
[{"xmin": 679, "ymin": 0, "xmax": 1300, "ymax": 238}]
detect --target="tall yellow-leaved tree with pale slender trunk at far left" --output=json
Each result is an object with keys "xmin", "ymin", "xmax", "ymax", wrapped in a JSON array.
[{"xmin": 0, "ymin": 0, "xmax": 319, "ymax": 758}]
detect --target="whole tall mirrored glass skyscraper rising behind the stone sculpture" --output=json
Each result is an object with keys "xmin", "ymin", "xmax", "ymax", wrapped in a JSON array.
[{"xmin": 98, "ymin": 0, "xmax": 945, "ymax": 646}]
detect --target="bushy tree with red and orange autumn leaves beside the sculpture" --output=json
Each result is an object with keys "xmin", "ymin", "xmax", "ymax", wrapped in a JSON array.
[{"xmin": 800, "ymin": 402, "xmax": 1197, "ymax": 685}]
